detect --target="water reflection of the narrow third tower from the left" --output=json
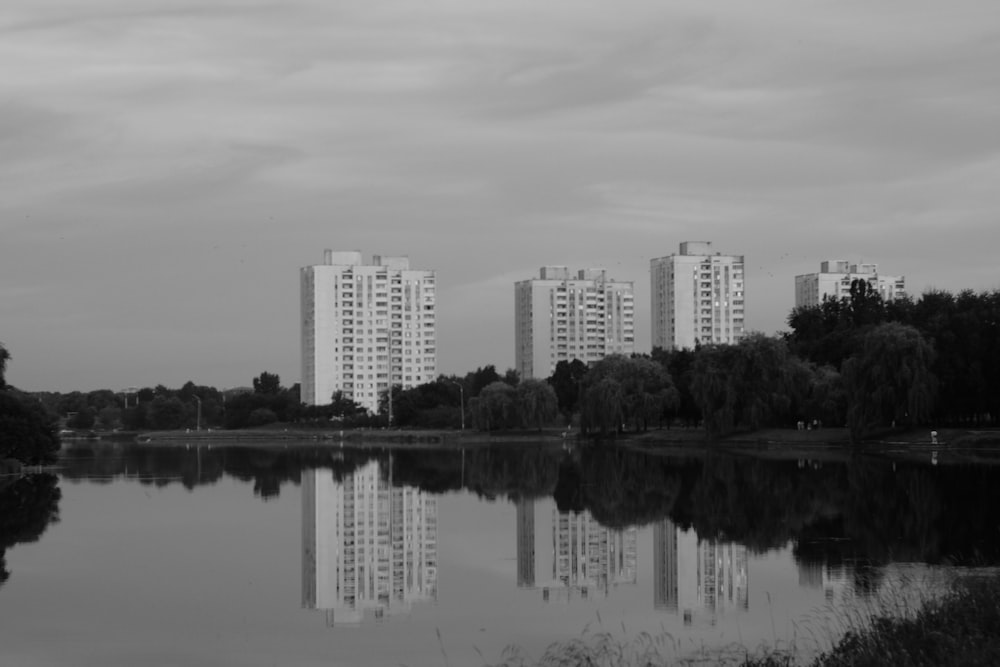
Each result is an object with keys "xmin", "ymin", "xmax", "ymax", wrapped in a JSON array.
[{"xmin": 653, "ymin": 519, "xmax": 749, "ymax": 623}]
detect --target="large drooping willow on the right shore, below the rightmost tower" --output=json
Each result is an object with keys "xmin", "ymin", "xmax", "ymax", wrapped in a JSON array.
[{"xmin": 843, "ymin": 322, "xmax": 937, "ymax": 441}]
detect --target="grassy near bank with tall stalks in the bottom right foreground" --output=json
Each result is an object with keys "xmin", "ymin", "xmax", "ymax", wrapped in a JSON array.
[{"xmin": 489, "ymin": 575, "xmax": 1000, "ymax": 667}]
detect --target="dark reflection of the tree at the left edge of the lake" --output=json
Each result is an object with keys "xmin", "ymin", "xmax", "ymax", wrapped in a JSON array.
[{"xmin": 0, "ymin": 473, "xmax": 61, "ymax": 585}]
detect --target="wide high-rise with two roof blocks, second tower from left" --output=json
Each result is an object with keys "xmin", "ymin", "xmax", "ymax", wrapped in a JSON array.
[{"xmin": 514, "ymin": 266, "xmax": 635, "ymax": 379}]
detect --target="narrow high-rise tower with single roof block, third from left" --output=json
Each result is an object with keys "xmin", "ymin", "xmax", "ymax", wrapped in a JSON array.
[{"xmin": 649, "ymin": 241, "xmax": 745, "ymax": 350}]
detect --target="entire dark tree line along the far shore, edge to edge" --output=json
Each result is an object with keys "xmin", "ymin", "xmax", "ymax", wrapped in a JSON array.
[{"xmin": 0, "ymin": 281, "xmax": 1000, "ymax": 468}]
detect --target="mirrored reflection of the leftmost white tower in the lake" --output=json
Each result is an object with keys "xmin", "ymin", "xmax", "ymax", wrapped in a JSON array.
[{"xmin": 302, "ymin": 461, "xmax": 437, "ymax": 625}]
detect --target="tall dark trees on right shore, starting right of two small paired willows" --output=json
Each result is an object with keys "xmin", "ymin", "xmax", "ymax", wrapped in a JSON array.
[{"xmin": 568, "ymin": 280, "xmax": 1000, "ymax": 440}]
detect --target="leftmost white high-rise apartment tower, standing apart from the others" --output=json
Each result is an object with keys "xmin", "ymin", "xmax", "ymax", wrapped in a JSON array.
[{"xmin": 300, "ymin": 250, "xmax": 437, "ymax": 412}]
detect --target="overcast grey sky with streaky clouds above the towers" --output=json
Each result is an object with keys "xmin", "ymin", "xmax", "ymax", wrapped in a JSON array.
[{"xmin": 0, "ymin": 0, "xmax": 1000, "ymax": 391}]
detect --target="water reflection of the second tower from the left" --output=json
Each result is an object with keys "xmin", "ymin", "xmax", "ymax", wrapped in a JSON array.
[{"xmin": 517, "ymin": 499, "xmax": 638, "ymax": 602}]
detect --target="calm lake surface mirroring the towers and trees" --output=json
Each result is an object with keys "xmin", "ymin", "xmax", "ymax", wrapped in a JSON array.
[{"xmin": 0, "ymin": 443, "xmax": 1000, "ymax": 667}]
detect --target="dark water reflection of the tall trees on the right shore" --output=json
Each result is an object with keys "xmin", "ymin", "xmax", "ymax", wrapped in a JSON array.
[{"xmin": 568, "ymin": 448, "xmax": 1000, "ymax": 568}]
